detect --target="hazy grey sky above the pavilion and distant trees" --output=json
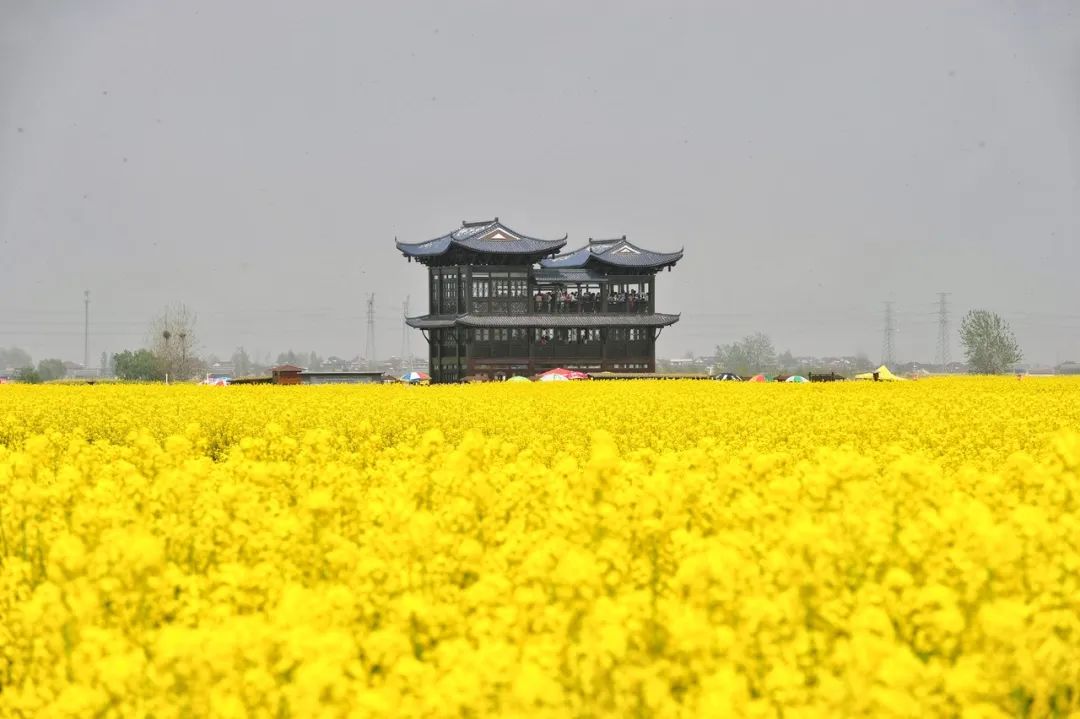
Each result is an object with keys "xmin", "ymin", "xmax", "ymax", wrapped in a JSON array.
[{"xmin": 0, "ymin": 0, "xmax": 1080, "ymax": 364}]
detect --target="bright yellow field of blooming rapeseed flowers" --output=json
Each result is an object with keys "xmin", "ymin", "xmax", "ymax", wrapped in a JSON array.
[{"xmin": 0, "ymin": 378, "xmax": 1080, "ymax": 717}]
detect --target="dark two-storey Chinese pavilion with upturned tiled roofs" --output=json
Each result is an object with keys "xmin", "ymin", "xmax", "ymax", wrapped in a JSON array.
[{"xmin": 396, "ymin": 217, "xmax": 683, "ymax": 382}]
